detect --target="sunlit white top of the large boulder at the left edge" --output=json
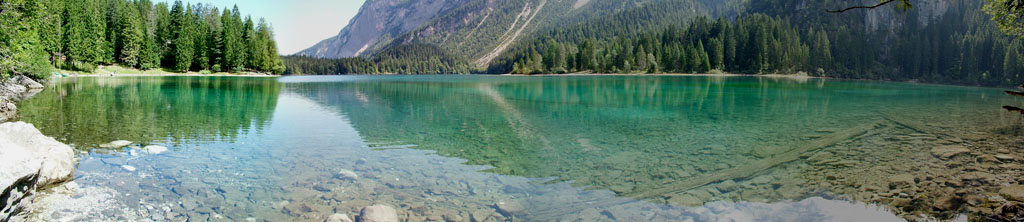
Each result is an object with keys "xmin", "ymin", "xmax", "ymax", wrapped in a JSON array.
[{"xmin": 0, "ymin": 122, "xmax": 75, "ymax": 186}]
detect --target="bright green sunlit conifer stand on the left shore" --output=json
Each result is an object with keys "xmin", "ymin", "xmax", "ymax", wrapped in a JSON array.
[{"xmin": 0, "ymin": 0, "xmax": 284, "ymax": 78}]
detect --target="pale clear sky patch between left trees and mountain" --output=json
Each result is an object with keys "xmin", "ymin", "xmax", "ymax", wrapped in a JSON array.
[{"xmin": 174, "ymin": 0, "xmax": 366, "ymax": 55}]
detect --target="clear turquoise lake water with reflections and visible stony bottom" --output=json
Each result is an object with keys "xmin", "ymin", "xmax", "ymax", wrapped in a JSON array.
[{"xmin": 12, "ymin": 76, "xmax": 1020, "ymax": 221}]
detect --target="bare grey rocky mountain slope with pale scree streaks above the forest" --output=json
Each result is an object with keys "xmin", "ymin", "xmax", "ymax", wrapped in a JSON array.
[{"xmin": 297, "ymin": 0, "xmax": 706, "ymax": 66}]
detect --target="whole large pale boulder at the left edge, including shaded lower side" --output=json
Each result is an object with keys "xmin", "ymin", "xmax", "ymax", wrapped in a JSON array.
[{"xmin": 0, "ymin": 122, "xmax": 75, "ymax": 221}]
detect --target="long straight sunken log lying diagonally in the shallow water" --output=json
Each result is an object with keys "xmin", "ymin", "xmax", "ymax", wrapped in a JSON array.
[{"xmin": 529, "ymin": 121, "xmax": 882, "ymax": 218}]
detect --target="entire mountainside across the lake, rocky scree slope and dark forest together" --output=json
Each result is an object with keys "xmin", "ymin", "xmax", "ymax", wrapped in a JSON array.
[{"xmin": 290, "ymin": 0, "xmax": 1024, "ymax": 86}]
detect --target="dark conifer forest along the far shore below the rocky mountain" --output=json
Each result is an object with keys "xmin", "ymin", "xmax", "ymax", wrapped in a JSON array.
[{"xmin": 278, "ymin": 0, "xmax": 1024, "ymax": 86}]
